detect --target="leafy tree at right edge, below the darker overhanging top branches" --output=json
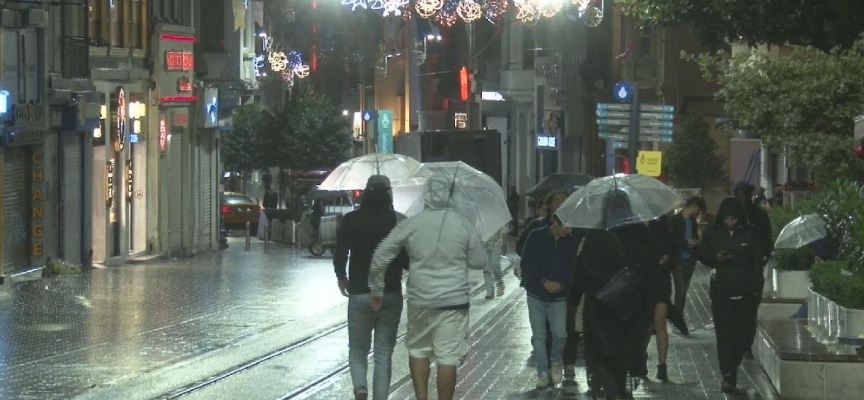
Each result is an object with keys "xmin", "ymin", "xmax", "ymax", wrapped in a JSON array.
[{"xmin": 691, "ymin": 39, "xmax": 864, "ymax": 177}]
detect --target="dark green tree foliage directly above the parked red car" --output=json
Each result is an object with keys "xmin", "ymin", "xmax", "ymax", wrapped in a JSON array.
[{"xmin": 219, "ymin": 104, "xmax": 267, "ymax": 172}]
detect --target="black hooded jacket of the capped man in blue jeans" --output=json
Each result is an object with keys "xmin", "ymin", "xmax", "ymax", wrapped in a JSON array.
[{"xmin": 333, "ymin": 188, "xmax": 408, "ymax": 294}]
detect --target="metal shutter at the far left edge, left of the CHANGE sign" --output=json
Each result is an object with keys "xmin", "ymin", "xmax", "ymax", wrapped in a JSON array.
[{"xmin": 3, "ymin": 147, "xmax": 31, "ymax": 272}]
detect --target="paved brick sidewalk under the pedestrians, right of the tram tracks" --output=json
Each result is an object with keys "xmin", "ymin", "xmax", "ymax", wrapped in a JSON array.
[{"xmin": 307, "ymin": 266, "xmax": 779, "ymax": 400}]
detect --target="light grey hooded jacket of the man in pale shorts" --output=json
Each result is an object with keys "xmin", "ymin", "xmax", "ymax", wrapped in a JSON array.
[{"xmin": 369, "ymin": 177, "xmax": 486, "ymax": 309}]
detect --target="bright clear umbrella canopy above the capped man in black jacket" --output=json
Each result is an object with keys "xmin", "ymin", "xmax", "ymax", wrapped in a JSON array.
[{"xmin": 319, "ymin": 153, "xmax": 420, "ymax": 190}]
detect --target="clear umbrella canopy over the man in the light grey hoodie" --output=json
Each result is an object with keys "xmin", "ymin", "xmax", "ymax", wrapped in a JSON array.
[{"xmin": 393, "ymin": 161, "xmax": 511, "ymax": 240}]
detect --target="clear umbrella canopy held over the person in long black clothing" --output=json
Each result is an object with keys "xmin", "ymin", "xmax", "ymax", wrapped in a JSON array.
[{"xmin": 555, "ymin": 174, "xmax": 681, "ymax": 230}]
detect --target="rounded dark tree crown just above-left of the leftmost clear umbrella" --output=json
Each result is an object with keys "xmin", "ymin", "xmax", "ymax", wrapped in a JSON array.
[{"xmin": 273, "ymin": 93, "xmax": 351, "ymax": 170}]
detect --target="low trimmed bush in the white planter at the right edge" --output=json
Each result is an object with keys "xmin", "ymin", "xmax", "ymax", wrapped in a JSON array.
[{"xmin": 810, "ymin": 260, "xmax": 864, "ymax": 310}]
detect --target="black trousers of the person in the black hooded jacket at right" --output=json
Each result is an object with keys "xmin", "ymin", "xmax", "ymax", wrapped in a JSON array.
[{"xmin": 711, "ymin": 293, "xmax": 762, "ymax": 376}]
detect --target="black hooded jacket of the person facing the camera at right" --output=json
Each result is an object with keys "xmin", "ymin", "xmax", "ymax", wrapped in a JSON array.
[{"xmin": 698, "ymin": 197, "xmax": 765, "ymax": 297}]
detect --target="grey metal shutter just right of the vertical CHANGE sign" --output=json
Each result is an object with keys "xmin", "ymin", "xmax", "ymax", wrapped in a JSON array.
[{"xmin": 61, "ymin": 133, "xmax": 84, "ymax": 264}]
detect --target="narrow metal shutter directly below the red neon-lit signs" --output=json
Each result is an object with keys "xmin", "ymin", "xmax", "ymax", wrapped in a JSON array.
[{"xmin": 168, "ymin": 134, "xmax": 183, "ymax": 256}]
